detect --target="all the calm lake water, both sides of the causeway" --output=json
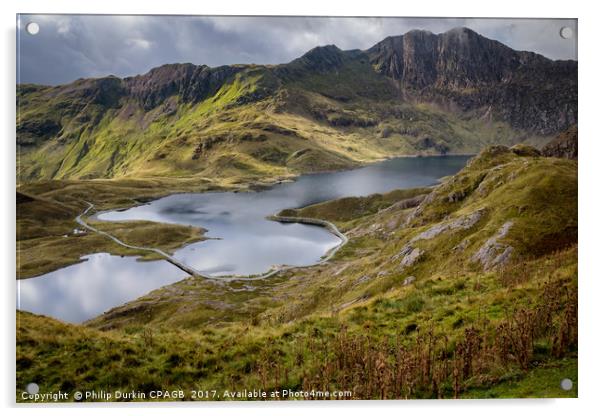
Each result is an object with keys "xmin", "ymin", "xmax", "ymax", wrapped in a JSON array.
[{"xmin": 18, "ymin": 156, "xmax": 468, "ymax": 322}]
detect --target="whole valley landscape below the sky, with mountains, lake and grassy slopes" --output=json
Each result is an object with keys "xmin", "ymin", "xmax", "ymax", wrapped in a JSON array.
[{"xmin": 16, "ymin": 28, "xmax": 578, "ymax": 401}]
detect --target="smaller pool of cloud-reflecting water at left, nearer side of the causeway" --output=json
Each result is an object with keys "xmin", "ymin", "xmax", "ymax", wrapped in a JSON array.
[{"xmin": 17, "ymin": 253, "xmax": 188, "ymax": 322}]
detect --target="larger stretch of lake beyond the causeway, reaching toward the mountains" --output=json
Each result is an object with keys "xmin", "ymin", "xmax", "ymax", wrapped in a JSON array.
[{"xmin": 98, "ymin": 156, "xmax": 468, "ymax": 276}]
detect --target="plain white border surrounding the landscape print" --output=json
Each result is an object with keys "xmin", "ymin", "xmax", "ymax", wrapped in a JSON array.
[{"xmin": 0, "ymin": 0, "xmax": 602, "ymax": 416}]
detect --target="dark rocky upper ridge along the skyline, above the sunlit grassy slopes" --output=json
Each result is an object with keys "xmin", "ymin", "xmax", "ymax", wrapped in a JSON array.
[{"xmin": 19, "ymin": 27, "xmax": 577, "ymax": 143}]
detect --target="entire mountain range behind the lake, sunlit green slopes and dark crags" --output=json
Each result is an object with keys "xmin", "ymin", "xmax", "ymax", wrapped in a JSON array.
[{"xmin": 17, "ymin": 28, "xmax": 577, "ymax": 182}]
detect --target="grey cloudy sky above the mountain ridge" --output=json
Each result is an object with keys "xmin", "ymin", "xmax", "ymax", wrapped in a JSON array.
[{"xmin": 17, "ymin": 15, "xmax": 577, "ymax": 85}]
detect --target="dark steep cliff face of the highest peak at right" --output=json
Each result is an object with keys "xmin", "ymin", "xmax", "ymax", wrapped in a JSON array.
[{"xmin": 366, "ymin": 28, "xmax": 577, "ymax": 134}]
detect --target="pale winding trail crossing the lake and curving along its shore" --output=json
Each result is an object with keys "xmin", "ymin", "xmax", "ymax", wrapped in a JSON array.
[{"xmin": 75, "ymin": 201, "xmax": 349, "ymax": 282}]
